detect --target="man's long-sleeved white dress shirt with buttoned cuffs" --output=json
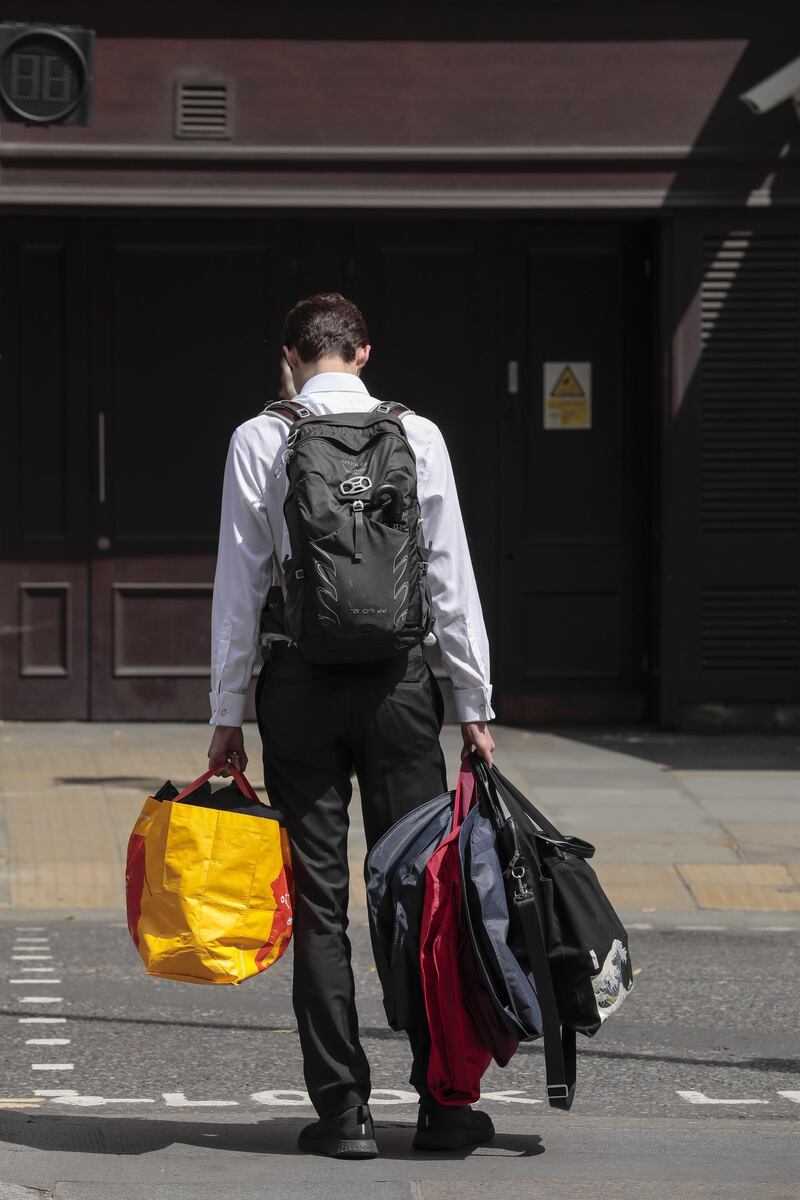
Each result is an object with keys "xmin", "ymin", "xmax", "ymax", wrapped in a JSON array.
[{"xmin": 209, "ymin": 372, "xmax": 494, "ymax": 726}]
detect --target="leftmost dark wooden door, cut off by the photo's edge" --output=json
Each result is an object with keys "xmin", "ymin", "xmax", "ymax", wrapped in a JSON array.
[{"xmin": 0, "ymin": 220, "xmax": 89, "ymax": 720}]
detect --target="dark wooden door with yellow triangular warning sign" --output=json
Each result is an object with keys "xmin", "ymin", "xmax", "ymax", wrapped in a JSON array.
[{"xmin": 497, "ymin": 222, "xmax": 652, "ymax": 721}]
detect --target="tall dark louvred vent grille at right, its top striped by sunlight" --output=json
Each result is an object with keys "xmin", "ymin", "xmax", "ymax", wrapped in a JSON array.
[{"xmin": 700, "ymin": 232, "xmax": 800, "ymax": 534}]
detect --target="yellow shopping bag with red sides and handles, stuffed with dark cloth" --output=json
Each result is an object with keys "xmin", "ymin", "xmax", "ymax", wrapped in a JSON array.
[{"xmin": 125, "ymin": 763, "xmax": 293, "ymax": 983}]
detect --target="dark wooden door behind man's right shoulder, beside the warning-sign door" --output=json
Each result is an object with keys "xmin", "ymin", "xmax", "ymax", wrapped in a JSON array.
[{"xmin": 351, "ymin": 218, "xmax": 498, "ymax": 718}]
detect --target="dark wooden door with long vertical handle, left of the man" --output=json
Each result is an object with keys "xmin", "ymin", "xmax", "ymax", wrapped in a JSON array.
[{"xmin": 90, "ymin": 221, "xmax": 291, "ymax": 720}]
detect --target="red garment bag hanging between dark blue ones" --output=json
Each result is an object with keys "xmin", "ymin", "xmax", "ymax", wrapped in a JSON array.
[{"xmin": 420, "ymin": 757, "xmax": 518, "ymax": 1105}]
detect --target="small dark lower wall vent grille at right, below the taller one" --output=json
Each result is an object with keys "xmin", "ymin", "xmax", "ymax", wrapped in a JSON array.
[{"xmin": 700, "ymin": 587, "xmax": 800, "ymax": 674}]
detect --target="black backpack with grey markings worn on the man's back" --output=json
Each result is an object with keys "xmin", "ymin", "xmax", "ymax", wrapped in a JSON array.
[{"xmin": 264, "ymin": 401, "xmax": 433, "ymax": 662}]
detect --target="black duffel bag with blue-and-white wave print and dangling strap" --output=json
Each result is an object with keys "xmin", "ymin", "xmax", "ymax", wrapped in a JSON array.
[{"xmin": 473, "ymin": 751, "xmax": 633, "ymax": 1109}]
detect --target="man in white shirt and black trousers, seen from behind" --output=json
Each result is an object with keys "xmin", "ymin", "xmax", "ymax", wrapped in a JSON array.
[{"xmin": 209, "ymin": 294, "xmax": 494, "ymax": 1158}]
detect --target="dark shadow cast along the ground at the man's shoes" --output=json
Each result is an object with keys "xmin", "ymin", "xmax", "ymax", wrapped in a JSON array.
[{"xmin": 0, "ymin": 1114, "xmax": 545, "ymax": 1163}]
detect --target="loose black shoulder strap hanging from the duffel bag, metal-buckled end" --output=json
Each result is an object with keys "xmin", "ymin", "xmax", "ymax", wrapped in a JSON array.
[{"xmin": 515, "ymin": 893, "xmax": 577, "ymax": 1111}]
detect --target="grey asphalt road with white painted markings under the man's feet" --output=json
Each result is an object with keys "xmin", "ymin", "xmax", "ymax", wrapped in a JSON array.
[{"xmin": 0, "ymin": 914, "xmax": 800, "ymax": 1200}]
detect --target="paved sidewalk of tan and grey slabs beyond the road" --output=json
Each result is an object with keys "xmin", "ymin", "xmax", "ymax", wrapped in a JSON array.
[{"xmin": 0, "ymin": 722, "xmax": 800, "ymax": 925}]
